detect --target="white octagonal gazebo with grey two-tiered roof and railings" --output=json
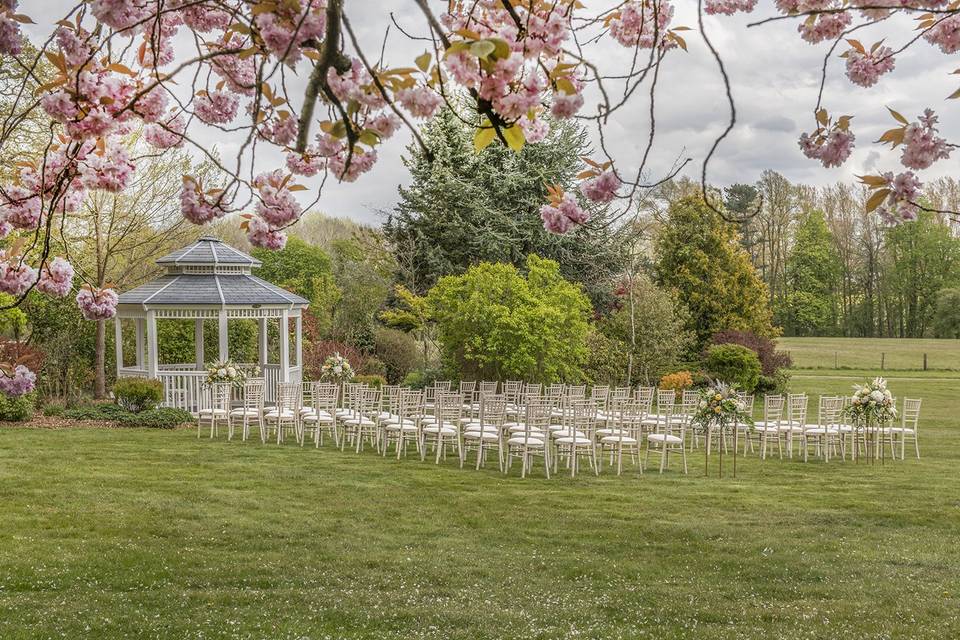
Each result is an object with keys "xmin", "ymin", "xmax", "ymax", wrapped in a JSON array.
[{"xmin": 115, "ymin": 236, "xmax": 308, "ymax": 412}]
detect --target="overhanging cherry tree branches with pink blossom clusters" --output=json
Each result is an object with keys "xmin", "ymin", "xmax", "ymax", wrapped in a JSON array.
[{"xmin": 0, "ymin": 0, "xmax": 960, "ymax": 389}]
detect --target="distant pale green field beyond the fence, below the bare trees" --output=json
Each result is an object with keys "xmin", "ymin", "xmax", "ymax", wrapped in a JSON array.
[{"xmin": 777, "ymin": 338, "xmax": 960, "ymax": 371}]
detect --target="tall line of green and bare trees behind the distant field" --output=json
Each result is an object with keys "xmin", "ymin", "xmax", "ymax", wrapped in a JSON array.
[{"xmin": 723, "ymin": 171, "xmax": 960, "ymax": 337}]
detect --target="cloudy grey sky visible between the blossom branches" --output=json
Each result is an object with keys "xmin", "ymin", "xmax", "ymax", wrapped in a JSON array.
[{"xmin": 20, "ymin": 0, "xmax": 960, "ymax": 223}]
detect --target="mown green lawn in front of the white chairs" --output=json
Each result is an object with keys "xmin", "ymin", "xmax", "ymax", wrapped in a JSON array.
[{"xmin": 0, "ymin": 372, "xmax": 960, "ymax": 640}]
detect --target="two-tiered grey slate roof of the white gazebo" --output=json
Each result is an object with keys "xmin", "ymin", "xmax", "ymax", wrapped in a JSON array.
[{"xmin": 120, "ymin": 236, "xmax": 309, "ymax": 308}]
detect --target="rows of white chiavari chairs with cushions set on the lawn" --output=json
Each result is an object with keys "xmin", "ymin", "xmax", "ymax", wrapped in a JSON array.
[{"xmin": 198, "ymin": 380, "xmax": 920, "ymax": 475}]
